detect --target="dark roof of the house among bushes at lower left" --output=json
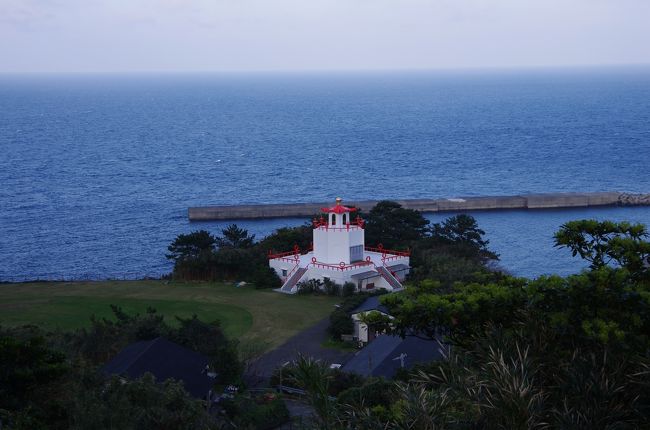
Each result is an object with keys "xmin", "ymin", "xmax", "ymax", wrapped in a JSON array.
[{"xmin": 101, "ymin": 337, "xmax": 214, "ymax": 399}]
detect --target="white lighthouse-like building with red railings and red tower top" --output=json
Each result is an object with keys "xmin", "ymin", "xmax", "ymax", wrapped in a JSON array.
[{"xmin": 269, "ymin": 198, "xmax": 410, "ymax": 294}]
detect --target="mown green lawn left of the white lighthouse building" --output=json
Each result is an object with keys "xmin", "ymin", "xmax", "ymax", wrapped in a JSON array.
[{"xmin": 0, "ymin": 281, "xmax": 338, "ymax": 349}]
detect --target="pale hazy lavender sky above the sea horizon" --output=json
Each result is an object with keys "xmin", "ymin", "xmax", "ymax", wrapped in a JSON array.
[{"xmin": 0, "ymin": 0, "xmax": 650, "ymax": 73}]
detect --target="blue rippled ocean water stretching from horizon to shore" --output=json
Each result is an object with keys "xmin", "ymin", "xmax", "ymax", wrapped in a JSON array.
[{"xmin": 0, "ymin": 68, "xmax": 650, "ymax": 280}]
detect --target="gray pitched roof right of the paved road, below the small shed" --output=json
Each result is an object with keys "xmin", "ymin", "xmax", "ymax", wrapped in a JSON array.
[{"xmin": 341, "ymin": 335, "xmax": 442, "ymax": 378}]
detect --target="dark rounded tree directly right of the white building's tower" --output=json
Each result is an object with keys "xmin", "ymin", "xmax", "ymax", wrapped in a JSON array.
[{"xmin": 365, "ymin": 200, "xmax": 429, "ymax": 248}]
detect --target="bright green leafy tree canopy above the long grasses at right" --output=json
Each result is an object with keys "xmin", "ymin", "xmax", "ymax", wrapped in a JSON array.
[{"xmin": 384, "ymin": 221, "xmax": 650, "ymax": 353}]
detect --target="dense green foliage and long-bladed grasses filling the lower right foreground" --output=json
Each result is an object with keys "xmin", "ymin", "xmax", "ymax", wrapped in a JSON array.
[{"xmin": 270, "ymin": 220, "xmax": 650, "ymax": 430}]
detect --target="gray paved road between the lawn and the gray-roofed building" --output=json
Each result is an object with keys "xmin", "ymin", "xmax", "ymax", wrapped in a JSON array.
[{"xmin": 247, "ymin": 318, "xmax": 353, "ymax": 386}]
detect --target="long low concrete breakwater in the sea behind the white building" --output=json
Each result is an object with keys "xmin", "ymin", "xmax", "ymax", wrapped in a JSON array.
[{"xmin": 188, "ymin": 192, "xmax": 650, "ymax": 221}]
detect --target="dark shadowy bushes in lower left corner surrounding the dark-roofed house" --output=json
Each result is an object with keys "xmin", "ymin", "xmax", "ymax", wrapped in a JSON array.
[{"xmin": 0, "ymin": 306, "xmax": 243, "ymax": 429}]
